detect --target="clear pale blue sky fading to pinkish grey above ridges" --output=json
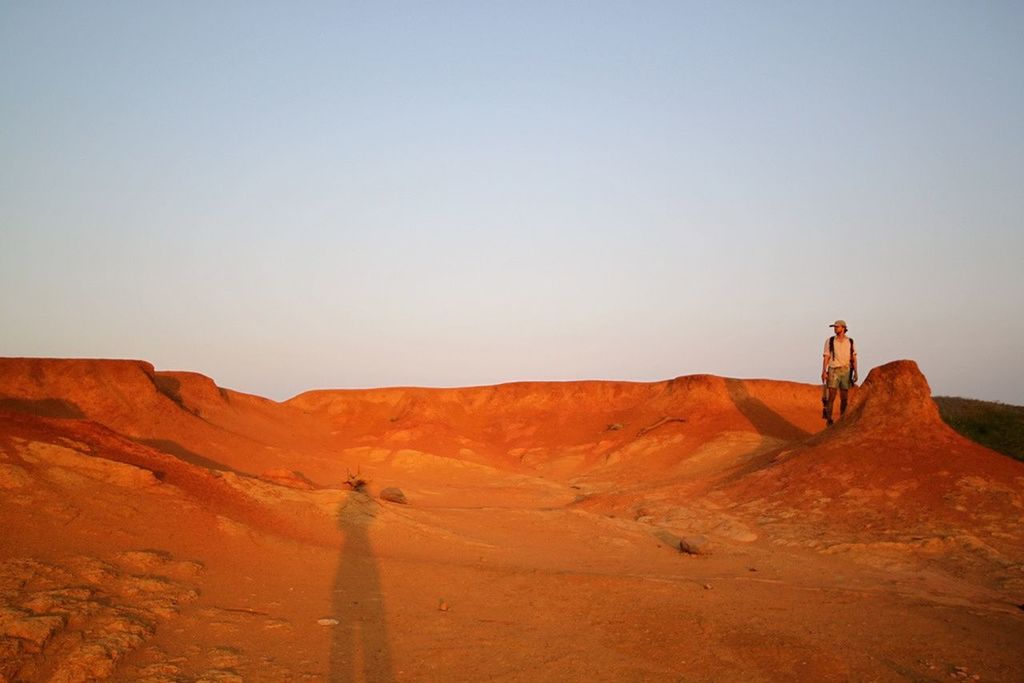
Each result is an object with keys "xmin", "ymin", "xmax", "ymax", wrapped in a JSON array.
[{"xmin": 0, "ymin": 0, "xmax": 1024, "ymax": 404}]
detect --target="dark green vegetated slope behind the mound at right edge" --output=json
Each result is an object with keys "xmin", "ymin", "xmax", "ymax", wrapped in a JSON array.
[{"xmin": 934, "ymin": 396, "xmax": 1024, "ymax": 461}]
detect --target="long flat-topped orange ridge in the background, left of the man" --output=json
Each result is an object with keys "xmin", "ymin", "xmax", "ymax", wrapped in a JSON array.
[{"xmin": 286, "ymin": 375, "xmax": 820, "ymax": 460}]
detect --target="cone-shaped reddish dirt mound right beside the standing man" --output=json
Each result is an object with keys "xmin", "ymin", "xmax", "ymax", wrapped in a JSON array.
[{"xmin": 723, "ymin": 360, "xmax": 1024, "ymax": 548}]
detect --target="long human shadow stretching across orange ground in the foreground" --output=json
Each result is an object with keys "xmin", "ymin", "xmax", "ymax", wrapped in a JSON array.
[{"xmin": 330, "ymin": 490, "xmax": 394, "ymax": 683}]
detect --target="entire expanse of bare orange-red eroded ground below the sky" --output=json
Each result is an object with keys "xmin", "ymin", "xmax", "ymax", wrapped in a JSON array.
[{"xmin": 0, "ymin": 358, "xmax": 1024, "ymax": 681}]
